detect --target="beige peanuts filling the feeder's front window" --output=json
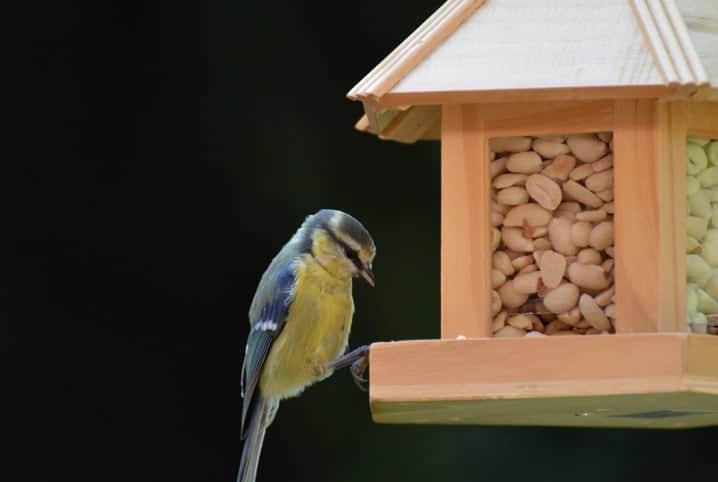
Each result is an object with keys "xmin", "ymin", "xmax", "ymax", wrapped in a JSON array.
[{"xmin": 489, "ymin": 132, "xmax": 616, "ymax": 337}]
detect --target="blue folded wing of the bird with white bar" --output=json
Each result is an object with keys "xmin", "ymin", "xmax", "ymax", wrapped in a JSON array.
[{"xmin": 242, "ymin": 265, "xmax": 296, "ymax": 438}]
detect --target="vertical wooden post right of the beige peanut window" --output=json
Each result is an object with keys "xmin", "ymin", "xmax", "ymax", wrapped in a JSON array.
[{"xmin": 613, "ymin": 100, "xmax": 664, "ymax": 333}]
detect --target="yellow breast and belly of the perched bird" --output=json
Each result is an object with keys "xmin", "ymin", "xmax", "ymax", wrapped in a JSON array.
[{"xmin": 259, "ymin": 257, "xmax": 354, "ymax": 399}]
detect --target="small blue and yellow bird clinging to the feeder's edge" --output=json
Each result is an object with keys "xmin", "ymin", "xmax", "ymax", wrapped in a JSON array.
[{"xmin": 237, "ymin": 209, "xmax": 376, "ymax": 482}]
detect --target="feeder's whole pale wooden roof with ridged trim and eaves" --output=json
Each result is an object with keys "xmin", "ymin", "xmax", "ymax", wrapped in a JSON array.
[{"xmin": 348, "ymin": 0, "xmax": 718, "ymax": 142}]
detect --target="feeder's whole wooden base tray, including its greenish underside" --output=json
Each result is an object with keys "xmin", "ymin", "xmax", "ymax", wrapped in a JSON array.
[{"xmin": 370, "ymin": 334, "xmax": 718, "ymax": 426}]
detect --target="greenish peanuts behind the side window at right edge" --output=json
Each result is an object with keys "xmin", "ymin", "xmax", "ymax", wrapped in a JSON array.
[{"xmin": 686, "ymin": 137, "xmax": 718, "ymax": 334}]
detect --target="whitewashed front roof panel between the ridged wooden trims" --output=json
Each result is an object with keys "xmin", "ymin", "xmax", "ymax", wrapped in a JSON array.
[{"xmin": 391, "ymin": 0, "xmax": 665, "ymax": 93}]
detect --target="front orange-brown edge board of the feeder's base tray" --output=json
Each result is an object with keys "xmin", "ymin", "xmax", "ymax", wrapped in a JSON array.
[{"xmin": 370, "ymin": 334, "xmax": 688, "ymax": 402}]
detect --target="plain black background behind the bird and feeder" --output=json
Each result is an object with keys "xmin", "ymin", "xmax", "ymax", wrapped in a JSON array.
[{"xmin": 11, "ymin": 0, "xmax": 718, "ymax": 482}]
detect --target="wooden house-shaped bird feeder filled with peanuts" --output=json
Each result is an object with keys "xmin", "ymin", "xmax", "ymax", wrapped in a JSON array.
[{"xmin": 348, "ymin": 0, "xmax": 718, "ymax": 428}]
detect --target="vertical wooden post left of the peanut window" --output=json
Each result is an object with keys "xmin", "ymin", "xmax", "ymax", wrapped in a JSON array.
[{"xmin": 441, "ymin": 106, "xmax": 491, "ymax": 339}]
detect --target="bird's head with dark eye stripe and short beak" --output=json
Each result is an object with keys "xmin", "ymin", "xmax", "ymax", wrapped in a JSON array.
[{"xmin": 297, "ymin": 209, "xmax": 376, "ymax": 286}]
